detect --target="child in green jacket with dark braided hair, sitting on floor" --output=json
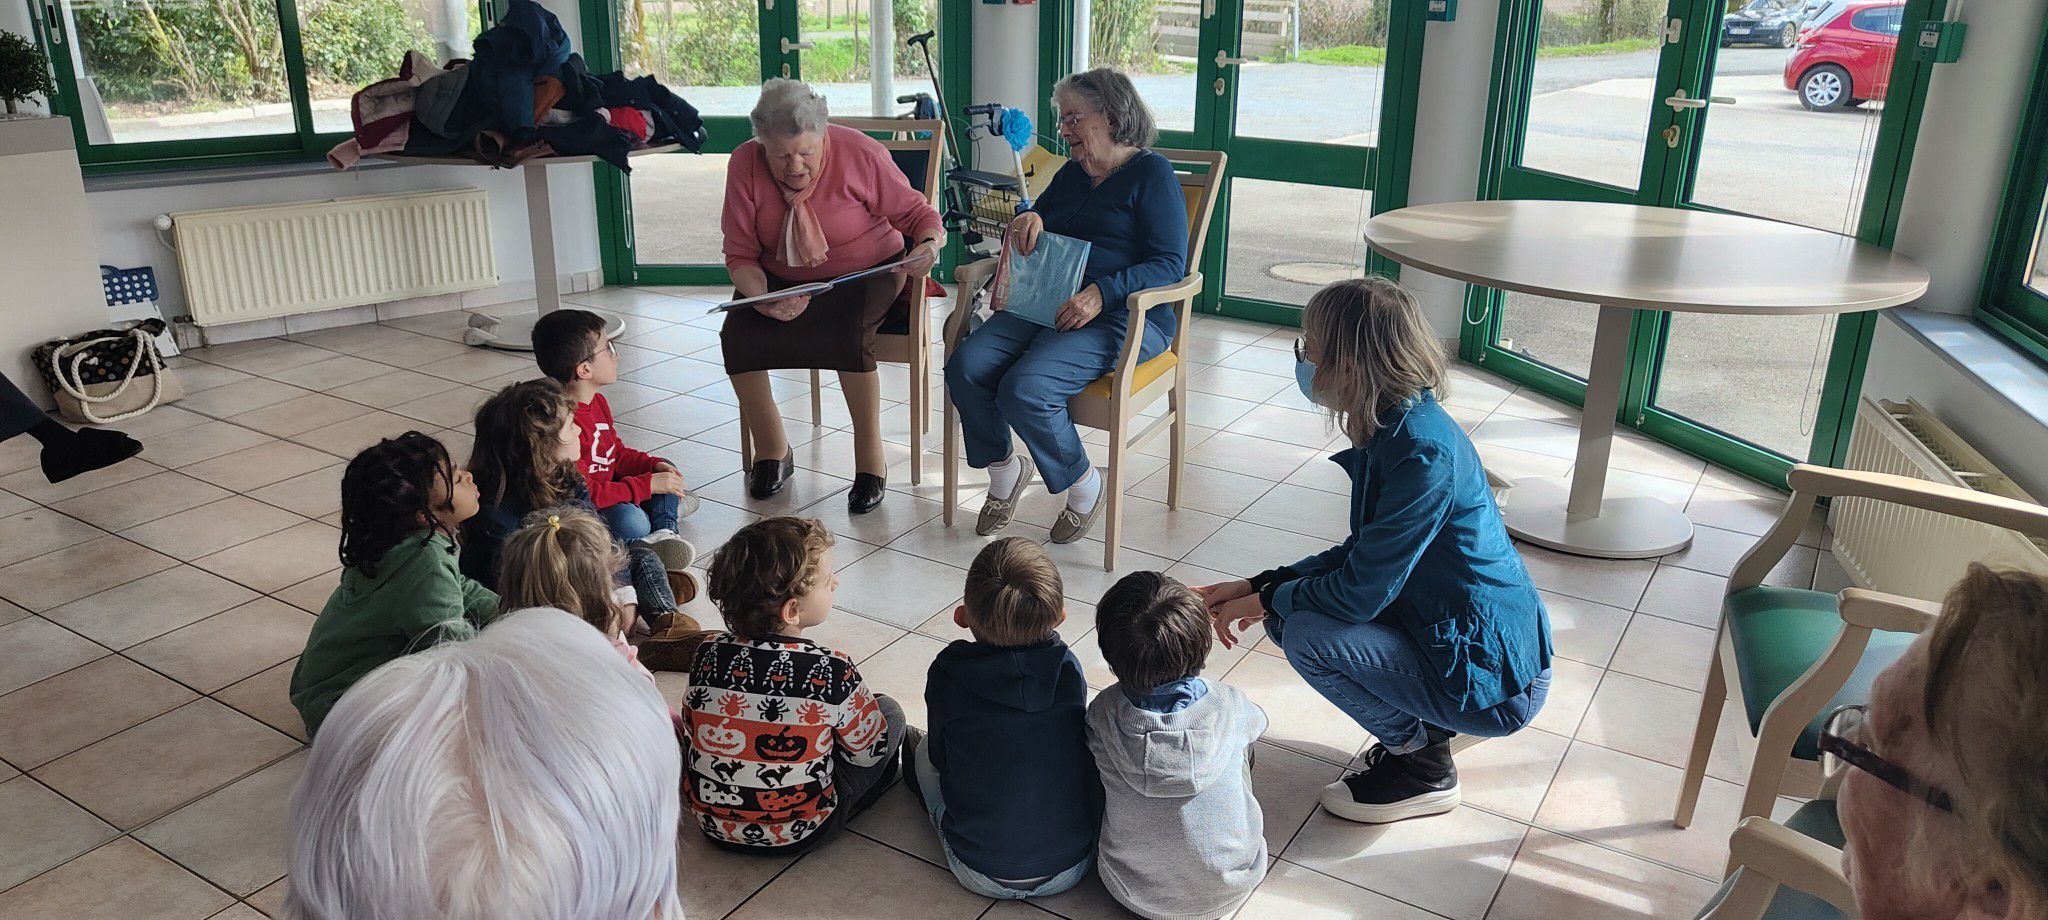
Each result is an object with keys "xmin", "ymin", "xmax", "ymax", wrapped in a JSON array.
[{"xmin": 291, "ymin": 430, "xmax": 498, "ymax": 736}]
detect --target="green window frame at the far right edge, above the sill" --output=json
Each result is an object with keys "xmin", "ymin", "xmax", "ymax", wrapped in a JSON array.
[{"xmin": 1976, "ymin": 16, "xmax": 2048, "ymax": 363}]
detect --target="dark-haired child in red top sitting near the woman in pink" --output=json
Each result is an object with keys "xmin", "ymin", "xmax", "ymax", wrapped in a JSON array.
[{"xmin": 532, "ymin": 309, "xmax": 696, "ymax": 551}]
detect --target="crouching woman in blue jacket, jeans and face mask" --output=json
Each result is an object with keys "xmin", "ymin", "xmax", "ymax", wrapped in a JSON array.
[{"xmin": 1198, "ymin": 279, "xmax": 1550, "ymax": 824}]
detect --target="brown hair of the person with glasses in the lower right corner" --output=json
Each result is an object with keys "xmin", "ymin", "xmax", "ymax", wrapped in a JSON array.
[{"xmin": 1919, "ymin": 563, "xmax": 2048, "ymax": 910}]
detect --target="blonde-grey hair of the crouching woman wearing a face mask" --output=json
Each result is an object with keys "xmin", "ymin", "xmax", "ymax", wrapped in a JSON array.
[{"xmin": 1300, "ymin": 277, "xmax": 1444, "ymax": 445}]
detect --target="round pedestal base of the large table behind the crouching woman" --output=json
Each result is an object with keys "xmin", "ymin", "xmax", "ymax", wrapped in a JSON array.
[{"xmin": 1501, "ymin": 477, "xmax": 1692, "ymax": 559}]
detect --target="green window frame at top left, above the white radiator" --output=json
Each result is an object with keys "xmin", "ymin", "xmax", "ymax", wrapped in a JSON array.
[{"xmin": 27, "ymin": 0, "xmax": 491, "ymax": 176}]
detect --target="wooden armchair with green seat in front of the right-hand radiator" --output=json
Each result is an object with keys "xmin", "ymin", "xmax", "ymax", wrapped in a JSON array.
[{"xmin": 1671, "ymin": 463, "xmax": 2048, "ymax": 828}]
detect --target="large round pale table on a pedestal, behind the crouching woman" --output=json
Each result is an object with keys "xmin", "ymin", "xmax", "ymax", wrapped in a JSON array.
[{"xmin": 1366, "ymin": 201, "xmax": 1927, "ymax": 559}]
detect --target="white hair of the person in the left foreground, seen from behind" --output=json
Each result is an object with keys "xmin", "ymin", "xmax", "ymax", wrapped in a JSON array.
[{"xmin": 287, "ymin": 609, "xmax": 682, "ymax": 920}]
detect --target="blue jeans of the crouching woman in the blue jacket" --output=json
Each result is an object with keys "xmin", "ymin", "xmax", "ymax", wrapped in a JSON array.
[{"xmin": 1266, "ymin": 611, "xmax": 1550, "ymax": 754}]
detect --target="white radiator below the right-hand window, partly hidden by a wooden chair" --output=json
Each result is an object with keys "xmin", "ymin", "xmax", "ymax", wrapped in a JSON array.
[{"xmin": 1829, "ymin": 398, "xmax": 2048, "ymax": 600}]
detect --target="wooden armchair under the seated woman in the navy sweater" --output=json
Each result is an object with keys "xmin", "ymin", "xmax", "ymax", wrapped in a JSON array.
[{"xmin": 944, "ymin": 150, "xmax": 1227, "ymax": 570}]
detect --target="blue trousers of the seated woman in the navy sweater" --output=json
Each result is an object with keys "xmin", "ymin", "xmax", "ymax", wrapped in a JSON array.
[{"xmin": 946, "ymin": 311, "xmax": 1167, "ymax": 494}]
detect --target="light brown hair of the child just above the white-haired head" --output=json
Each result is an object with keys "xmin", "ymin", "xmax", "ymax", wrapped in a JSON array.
[{"xmin": 498, "ymin": 508, "xmax": 627, "ymax": 635}]
